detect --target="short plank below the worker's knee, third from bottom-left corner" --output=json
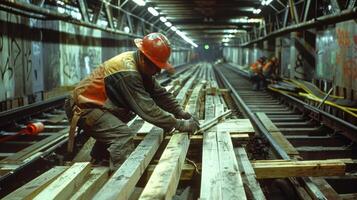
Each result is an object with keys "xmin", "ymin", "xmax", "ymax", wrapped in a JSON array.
[{"xmin": 70, "ymin": 167, "xmax": 109, "ymax": 200}]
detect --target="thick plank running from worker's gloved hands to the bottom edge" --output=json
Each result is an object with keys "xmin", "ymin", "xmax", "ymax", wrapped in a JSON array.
[{"xmin": 139, "ymin": 133, "xmax": 189, "ymax": 200}]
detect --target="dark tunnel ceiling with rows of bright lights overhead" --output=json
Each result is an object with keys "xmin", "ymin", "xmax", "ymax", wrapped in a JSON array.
[{"xmin": 11, "ymin": 0, "xmax": 289, "ymax": 44}]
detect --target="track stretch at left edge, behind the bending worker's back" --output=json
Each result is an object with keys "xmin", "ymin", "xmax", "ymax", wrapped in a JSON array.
[{"xmin": 0, "ymin": 96, "xmax": 68, "ymax": 196}]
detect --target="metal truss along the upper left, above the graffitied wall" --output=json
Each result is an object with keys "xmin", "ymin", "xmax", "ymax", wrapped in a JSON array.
[{"xmin": 0, "ymin": 0, "xmax": 189, "ymax": 50}]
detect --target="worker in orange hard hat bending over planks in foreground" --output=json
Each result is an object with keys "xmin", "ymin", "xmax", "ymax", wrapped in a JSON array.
[{"xmin": 65, "ymin": 33, "xmax": 199, "ymax": 170}]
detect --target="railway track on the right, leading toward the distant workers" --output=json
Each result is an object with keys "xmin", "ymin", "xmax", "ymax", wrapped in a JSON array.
[{"xmin": 215, "ymin": 64, "xmax": 357, "ymax": 199}]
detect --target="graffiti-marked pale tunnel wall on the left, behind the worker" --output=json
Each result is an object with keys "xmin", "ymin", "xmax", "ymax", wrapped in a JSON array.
[{"xmin": 0, "ymin": 11, "xmax": 190, "ymax": 104}]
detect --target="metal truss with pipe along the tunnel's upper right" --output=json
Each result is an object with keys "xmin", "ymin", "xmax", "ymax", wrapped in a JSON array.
[{"xmin": 237, "ymin": 0, "xmax": 357, "ymax": 47}]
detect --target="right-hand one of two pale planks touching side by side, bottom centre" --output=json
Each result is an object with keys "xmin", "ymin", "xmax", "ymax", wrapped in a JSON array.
[{"xmin": 217, "ymin": 129, "xmax": 247, "ymax": 199}]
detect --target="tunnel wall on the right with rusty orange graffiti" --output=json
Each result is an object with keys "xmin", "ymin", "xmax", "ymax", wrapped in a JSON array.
[{"xmin": 223, "ymin": 20, "xmax": 357, "ymax": 100}]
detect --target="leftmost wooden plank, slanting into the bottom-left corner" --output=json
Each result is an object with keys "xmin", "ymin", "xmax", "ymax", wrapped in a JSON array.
[{"xmin": 3, "ymin": 166, "xmax": 68, "ymax": 200}]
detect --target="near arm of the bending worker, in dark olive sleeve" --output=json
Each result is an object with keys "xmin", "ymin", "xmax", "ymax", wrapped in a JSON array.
[{"xmin": 105, "ymin": 72, "xmax": 177, "ymax": 130}]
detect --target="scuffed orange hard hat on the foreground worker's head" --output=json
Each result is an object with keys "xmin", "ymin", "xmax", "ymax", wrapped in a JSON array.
[{"xmin": 134, "ymin": 33, "xmax": 173, "ymax": 71}]
